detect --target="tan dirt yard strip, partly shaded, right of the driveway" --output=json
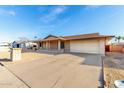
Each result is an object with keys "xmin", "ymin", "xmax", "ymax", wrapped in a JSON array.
[{"xmin": 104, "ymin": 53, "xmax": 124, "ymax": 88}]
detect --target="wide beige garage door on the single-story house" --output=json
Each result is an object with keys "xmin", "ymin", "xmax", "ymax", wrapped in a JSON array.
[{"xmin": 70, "ymin": 40, "xmax": 100, "ymax": 53}]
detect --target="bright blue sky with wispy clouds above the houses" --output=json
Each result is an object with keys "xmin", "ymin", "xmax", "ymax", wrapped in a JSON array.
[{"xmin": 0, "ymin": 5, "xmax": 124, "ymax": 42}]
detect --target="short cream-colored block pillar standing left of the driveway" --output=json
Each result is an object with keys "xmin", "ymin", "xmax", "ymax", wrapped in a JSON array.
[{"xmin": 11, "ymin": 48, "xmax": 22, "ymax": 61}]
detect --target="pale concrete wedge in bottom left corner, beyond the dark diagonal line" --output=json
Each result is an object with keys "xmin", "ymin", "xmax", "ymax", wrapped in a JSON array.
[{"xmin": 0, "ymin": 63, "xmax": 27, "ymax": 88}]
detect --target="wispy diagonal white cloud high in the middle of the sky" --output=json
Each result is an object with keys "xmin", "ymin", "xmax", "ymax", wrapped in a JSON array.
[{"xmin": 41, "ymin": 6, "xmax": 67, "ymax": 23}]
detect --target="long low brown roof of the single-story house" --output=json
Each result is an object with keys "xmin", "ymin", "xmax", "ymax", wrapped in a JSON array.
[{"xmin": 33, "ymin": 33, "xmax": 114, "ymax": 41}]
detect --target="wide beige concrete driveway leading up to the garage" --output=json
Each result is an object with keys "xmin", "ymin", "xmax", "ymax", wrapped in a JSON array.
[{"xmin": 0, "ymin": 53, "xmax": 101, "ymax": 88}]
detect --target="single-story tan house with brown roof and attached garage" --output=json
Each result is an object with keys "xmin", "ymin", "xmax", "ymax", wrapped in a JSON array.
[{"xmin": 34, "ymin": 33, "xmax": 114, "ymax": 54}]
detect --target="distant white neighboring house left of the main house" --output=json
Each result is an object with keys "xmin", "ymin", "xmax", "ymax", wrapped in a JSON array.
[{"xmin": 12, "ymin": 41, "xmax": 37, "ymax": 49}]
